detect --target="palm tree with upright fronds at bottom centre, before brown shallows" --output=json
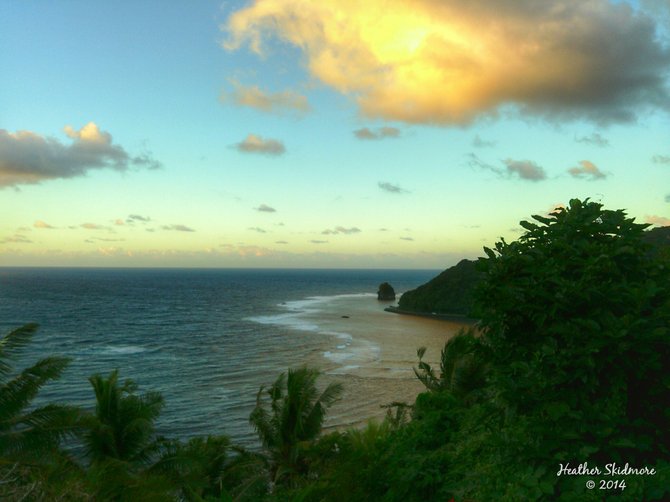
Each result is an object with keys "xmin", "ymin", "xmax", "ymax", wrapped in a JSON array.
[{"xmin": 249, "ymin": 367, "xmax": 342, "ymax": 486}]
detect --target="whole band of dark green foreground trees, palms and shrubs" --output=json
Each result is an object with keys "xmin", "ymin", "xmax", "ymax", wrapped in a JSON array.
[{"xmin": 0, "ymin": 199, "xmax": 670, "ymax": 502}]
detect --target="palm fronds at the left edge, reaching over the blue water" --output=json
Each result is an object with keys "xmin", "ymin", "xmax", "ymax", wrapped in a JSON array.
[{"xmin": 0, "ymin": 323, "xmax": 80, "ymax": 460}]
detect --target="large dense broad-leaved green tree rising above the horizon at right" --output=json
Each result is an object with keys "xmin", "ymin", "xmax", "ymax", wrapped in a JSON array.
[{"xmin": 475, "ymin": 199, "xmax": 670, "ymax": 499}]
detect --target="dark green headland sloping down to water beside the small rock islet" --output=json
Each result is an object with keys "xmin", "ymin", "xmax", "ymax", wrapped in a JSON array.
[{"xmin": 398, "ymin": 260, "xmax": 481, "ymax": 316}]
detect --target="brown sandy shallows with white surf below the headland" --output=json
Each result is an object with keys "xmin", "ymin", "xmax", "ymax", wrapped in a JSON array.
[{"xmin": 258, "ymin": 294, "xmax": 472, "ymax": 428}]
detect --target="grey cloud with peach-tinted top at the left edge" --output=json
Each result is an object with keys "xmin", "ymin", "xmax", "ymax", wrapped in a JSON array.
[{"xmin": 0, "ymin": 122, "xmax": 160, "ymax": 187}]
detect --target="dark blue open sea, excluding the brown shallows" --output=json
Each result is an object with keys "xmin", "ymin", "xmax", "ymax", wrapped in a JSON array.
[{"xmin": 0, "ymin": 268, "xmax": 436, "ymax": 445}]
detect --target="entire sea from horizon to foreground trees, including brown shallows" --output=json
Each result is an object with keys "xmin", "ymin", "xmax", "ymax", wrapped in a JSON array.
[{"xmin": 0, "ymin": 268, "xmax": 464, "ymax": 448}]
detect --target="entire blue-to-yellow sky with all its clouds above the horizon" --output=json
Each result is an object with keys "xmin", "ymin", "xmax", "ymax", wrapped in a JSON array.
[{"xmin": 0, "ymin": 0, "xmax": 670, "ymax": 269}]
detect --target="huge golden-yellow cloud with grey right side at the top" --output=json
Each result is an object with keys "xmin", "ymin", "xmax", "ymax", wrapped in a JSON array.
[{"xmin": 222, "ymin": 0, "xmax": 670, "ymax": 125}]
